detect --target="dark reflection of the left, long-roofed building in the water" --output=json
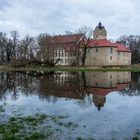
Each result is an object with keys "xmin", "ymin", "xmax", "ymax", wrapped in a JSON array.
[{"xmin": 39, "ymin": 72, "xmax": 83, "ymax": 100}]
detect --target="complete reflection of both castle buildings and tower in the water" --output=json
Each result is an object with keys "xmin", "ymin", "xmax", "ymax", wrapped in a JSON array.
[{"xmin": 39, "ymin": 72, "xmax": 131, "ymax": 110}]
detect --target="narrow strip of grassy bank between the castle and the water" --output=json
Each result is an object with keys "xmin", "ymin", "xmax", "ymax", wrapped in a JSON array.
[{"xmin": 0, "ymin": 65, "xmax": 140, "ymax": 72}]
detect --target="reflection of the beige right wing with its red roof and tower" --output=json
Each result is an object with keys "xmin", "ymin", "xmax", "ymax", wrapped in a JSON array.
[{"xmin": 82, "ymin": 72, "xmax": 131, "ymax": 110}]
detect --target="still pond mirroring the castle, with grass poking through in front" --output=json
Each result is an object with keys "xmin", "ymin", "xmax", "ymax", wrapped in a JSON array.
[{"xmin": 0, "ymin": 71, "xmax": 140, "ymax": 140}]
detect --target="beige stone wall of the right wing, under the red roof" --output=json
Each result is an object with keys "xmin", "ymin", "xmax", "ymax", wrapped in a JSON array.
[{"xmin": 82, "ymin": 47, "xmax": 131, "ymax": 66}]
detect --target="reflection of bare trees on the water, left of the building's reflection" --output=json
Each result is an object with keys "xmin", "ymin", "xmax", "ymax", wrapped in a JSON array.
[{"xmin": 0, "ymin": 72, "xmax": 37, "ymax": 100}]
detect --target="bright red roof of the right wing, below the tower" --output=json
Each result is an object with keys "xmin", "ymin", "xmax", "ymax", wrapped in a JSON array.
[{"xmin": 88, "ymin": 39, "xmax": 131, "ymax": 52}]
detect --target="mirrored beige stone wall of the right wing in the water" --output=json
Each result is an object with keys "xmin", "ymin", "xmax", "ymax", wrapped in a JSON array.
[{"xmin": 85, "ymin": 72, "xmax": 131, "ymax": 88}]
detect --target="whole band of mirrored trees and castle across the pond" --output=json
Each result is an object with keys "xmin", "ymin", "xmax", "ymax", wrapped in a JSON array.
[{"xmin": 0, "ymin": 72, "xmax": 133, "ymax": 110}]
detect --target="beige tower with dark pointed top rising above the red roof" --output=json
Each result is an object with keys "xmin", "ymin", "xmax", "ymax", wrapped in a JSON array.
[{"xmin": 93, "ymin": 22, "xmax": 107, "ymax": 40}]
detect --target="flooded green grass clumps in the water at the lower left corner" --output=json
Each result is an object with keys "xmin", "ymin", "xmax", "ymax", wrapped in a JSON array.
[{"xmin": 0, "ymin": 114, "xmax": 78, "ymax": 140}]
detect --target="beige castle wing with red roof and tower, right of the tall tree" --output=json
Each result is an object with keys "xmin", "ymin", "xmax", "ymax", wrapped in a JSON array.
[{"xmin": 81, "ymin": 23, "xmax": 131, "ymax": 66}]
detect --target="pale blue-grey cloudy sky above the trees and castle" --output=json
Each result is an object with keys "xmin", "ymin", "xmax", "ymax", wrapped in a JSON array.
[{"xmin": 0, "ymin": 0, "xmax": 140, "ymax": 39}]
